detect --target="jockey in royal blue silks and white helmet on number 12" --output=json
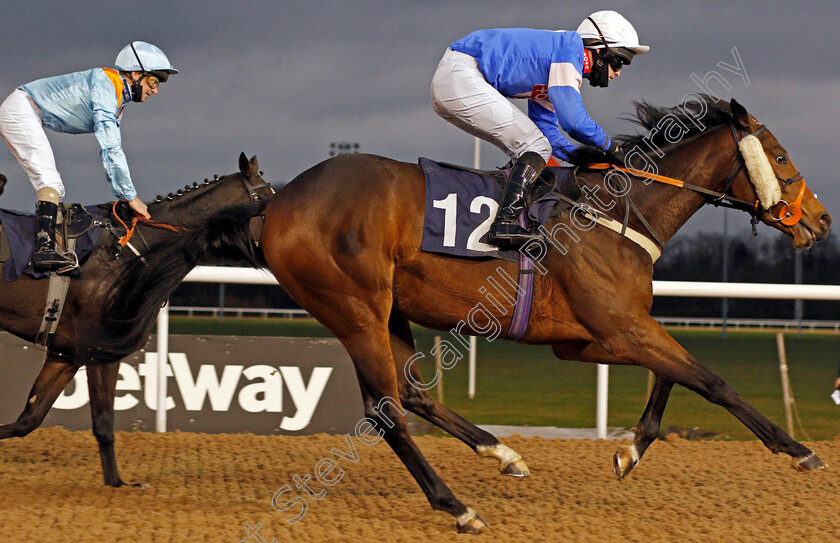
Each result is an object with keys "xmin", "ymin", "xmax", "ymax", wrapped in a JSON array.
[{"xmin": 432, "ymin": 11, "xmax": 649, "ymax": 249}]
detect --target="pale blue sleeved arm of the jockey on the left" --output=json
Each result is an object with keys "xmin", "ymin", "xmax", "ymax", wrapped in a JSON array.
[{"xmin": 91, "ymin": 73, "xmax": 137, "ymax": 201}]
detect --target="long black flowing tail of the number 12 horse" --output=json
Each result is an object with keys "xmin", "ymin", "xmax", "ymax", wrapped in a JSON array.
[{"xmin": 79, "ymin": 200, "xmax": 267, "ymax": 361}]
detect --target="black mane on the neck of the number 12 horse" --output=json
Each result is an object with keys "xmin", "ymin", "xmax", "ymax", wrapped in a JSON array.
[{"xmin": 571, "ymin": 94, "xmax": 732, "ymax": 164}]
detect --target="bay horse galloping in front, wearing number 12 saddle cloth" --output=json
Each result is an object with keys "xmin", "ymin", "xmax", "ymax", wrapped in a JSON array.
[{"xmin": 116, "ymin": 97, "xmax": 831, "ymax": 533}]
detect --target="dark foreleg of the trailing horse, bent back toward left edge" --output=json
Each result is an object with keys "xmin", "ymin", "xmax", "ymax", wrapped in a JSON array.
[{"xmin": 0, "ymin": 353, "xmax": 79, "ymax": 439}]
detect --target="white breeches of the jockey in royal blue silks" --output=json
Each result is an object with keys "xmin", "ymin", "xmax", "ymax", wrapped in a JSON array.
[{"xmin": 432, "ymin": 49, "xmax": 551, "ymax": 161}]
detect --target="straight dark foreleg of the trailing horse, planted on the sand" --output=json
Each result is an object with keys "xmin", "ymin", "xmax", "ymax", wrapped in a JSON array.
[{"xmin": 87, "ymin": 362, "xmax": 132, "ymax": 487}]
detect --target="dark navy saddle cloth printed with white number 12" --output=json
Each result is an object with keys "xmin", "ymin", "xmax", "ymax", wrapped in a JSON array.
[{"xmin": 420, "ymin": 158, "xmax": 571, "ymax": 262}]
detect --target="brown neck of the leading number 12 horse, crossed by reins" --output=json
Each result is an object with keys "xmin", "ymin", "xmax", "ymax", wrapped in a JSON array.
[{"xmin": 631, "ymin": 127, "xmax": 737, "ymax": 243}]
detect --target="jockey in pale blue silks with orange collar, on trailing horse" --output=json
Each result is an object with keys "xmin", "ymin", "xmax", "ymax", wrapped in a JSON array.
[{"xmin": 0, "ymin": 41, "xmax": 178, "ymax": 271}]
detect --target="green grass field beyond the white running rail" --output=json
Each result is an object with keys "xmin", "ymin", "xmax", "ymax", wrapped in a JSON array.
[{"xmin": 170, "ymin": 317, "xmax": 840, "ymax": 440}]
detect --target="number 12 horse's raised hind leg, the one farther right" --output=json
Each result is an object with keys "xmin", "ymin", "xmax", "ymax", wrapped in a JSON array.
[{"xmin": 388, "ymin": 312, "xmax": 530, "ymax": 477}]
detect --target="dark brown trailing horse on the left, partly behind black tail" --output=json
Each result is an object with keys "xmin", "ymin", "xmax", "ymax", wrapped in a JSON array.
[{"xmin": 0, "ymin": 153, "xmax": 273, "ymax": 487}]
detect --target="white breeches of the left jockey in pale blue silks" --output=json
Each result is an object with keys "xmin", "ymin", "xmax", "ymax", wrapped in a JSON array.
[{"xmin": 0, "ymin": 89, "xmax": 64, "ymax": 198}]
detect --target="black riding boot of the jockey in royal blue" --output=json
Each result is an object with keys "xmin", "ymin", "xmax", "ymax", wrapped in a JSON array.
[{"xmin": 487, "ymin": 151, "xmax": 545, "ymax": 249}]
